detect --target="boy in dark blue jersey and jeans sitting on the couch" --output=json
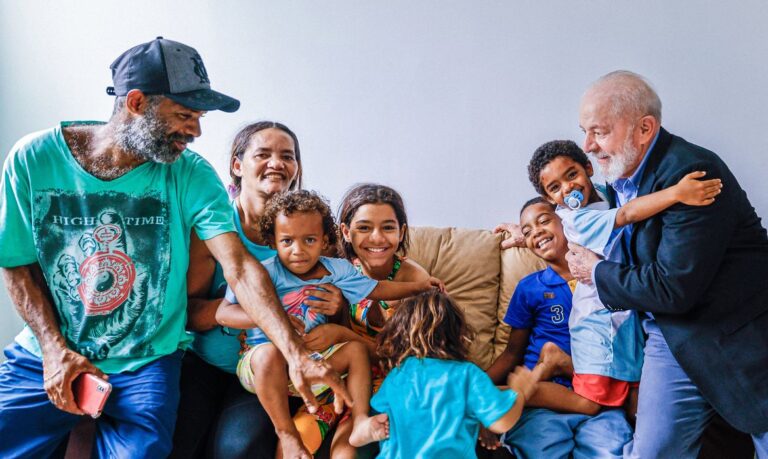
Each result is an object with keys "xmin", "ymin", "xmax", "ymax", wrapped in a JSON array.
[{"xmin": 480, "ymin": 198, "xmax": 632, "ymax": 457}]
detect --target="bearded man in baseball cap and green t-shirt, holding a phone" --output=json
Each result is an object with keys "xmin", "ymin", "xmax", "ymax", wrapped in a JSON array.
[{"xmin": 0, "ymin": 37, "xmax": 349, "ymax": 457}]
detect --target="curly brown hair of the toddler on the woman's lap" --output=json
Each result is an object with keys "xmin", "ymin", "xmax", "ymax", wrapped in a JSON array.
[{"xmin": 259, "ymin": 190, "xmax": 338, "ymax": 247}]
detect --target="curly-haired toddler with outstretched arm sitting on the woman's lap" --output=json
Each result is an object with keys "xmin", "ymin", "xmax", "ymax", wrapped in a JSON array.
[{"xmin": 216, "ymin": 190, "xmax": 443, "ymax": 458}]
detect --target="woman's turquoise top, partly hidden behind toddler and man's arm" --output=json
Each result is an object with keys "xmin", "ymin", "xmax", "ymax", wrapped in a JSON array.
[{"xmin": 189, "ymin": 201, "xmax": 277, "ymax": 374}]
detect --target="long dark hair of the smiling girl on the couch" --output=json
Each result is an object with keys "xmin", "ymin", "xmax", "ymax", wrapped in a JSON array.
[{"xmin": 339, "ymin": 183, "xmax": 410, "ymax": 260}]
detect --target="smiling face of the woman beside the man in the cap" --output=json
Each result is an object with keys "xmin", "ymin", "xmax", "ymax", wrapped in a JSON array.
[{"xmin": 232, "ymin": 128, "xmax": 299, "ymax": 196}]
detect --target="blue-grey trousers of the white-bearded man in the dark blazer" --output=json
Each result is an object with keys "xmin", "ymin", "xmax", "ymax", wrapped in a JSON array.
[{"xmin": 626, "ymin": 319, "xmax": 768, "ymax": 459}]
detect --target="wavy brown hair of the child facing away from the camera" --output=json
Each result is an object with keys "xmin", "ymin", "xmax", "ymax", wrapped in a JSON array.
[{"xmin": 376, "ymin": 289, "xmax": 474, "ymax": 371}]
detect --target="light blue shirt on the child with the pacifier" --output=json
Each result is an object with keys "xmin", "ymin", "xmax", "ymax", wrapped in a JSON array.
[{"xmin": 556, "ymin": 187, "xmax": 643, "ymax": 381}]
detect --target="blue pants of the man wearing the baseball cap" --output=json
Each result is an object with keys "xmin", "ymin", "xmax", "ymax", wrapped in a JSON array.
[{"xmin": 0, "ymin": 343, "xmax": 182, "ymax": 458}]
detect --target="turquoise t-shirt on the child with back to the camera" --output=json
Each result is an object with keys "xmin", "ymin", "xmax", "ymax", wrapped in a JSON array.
[{"xmin": 371, "ymin": 357, "xmax": 517, "ymax": 459}]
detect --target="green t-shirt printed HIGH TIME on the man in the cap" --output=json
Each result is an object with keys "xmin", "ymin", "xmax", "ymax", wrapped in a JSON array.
[{"xmin": 0, "ymin": 122, "xmax": 235, "ymax": 373}]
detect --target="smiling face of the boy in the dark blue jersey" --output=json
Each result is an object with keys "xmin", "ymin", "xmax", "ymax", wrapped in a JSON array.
[{"xmin": 520, "ymin": 203, "xmax": 568, "ymax": 263}]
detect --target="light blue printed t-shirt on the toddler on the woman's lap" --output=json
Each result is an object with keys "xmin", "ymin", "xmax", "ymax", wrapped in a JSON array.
[{"xmin": 226, "ymin": 256, "xmax": 378, "ymax": 346}]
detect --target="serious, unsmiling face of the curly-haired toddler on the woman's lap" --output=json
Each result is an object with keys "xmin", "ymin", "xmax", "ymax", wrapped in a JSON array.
[{"xmin": 274, "ymin": 212, "xmax": 328, "ymax": 280}]
